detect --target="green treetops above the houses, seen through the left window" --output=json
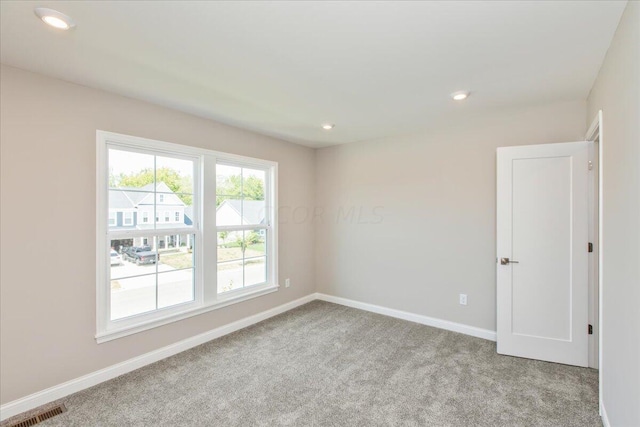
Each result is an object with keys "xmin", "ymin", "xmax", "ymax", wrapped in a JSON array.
[{"xmin": 109, "ymin": 167, "xmax": 193, "ymax": 206}]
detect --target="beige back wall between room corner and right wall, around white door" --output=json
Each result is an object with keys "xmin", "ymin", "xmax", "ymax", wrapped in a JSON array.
[{"xmin": 316, "ymin": 102, "xmax": 586, "ymax": 330}]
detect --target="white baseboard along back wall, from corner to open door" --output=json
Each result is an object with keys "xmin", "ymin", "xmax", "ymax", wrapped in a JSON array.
[{"xmin": 316, "ymin": 293, "xmax": 496, "ymax": 341}]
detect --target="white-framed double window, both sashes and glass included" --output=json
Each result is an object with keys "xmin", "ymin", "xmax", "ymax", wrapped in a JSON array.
[{"xmin": 96, "ymin": 131, "xmax": 278, "ymax": 342}]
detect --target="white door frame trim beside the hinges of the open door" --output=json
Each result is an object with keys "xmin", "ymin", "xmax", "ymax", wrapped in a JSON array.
[{"xmin": 585, "ymin": 110, "xmax": 604, "ymax": 416}]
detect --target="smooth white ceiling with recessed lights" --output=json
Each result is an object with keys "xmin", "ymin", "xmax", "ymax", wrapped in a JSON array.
[{"xmin": 0, "ymin": 1, "xmax": 626, "ymax": 147}]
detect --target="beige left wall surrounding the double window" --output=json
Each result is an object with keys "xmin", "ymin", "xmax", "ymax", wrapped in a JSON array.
[{"xmin": 0, "ymin": 66, "xmax": 315, "ymax": 404}]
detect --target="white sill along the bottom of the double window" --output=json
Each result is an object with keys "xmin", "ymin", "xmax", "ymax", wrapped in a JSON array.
[{"xmin": 95, "ymin": 285, "xmax": 279, "ymax": 344}]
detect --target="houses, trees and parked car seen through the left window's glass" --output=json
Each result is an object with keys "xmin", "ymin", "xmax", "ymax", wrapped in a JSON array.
[{"xmin": 108, "ymin": 149, "xmax": 197, "ymax": 320}]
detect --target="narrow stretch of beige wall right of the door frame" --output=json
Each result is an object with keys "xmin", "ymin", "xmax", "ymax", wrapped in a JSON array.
[{"xmin": 587, "ymin": 1, "xmax": 640, "ymax": 426}]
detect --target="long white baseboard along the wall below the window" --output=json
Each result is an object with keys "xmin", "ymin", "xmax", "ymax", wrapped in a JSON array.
[{"xmin": 0, "ymin": 294, "xmax": 316, "ymax": 421}]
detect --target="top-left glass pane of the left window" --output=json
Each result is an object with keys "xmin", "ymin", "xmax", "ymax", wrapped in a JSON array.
[{"xmin": 109, "ymin": 148, "xmax": 154, "ymax": 191}]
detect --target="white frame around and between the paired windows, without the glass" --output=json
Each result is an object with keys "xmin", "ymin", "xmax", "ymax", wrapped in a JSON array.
[{"xmin": 95, "ymin": 130, "xmax": 279, "ymax": 343}]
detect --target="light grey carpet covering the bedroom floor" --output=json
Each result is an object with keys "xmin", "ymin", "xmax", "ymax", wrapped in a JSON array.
[{"xmin": 31, "ymin": 301, "xmax": 602, "ymax": 427}]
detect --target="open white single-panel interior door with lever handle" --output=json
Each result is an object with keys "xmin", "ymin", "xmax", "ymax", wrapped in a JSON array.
[{"xmin": 497, "ymin": 142, "xmax": 592, "ymax": 366}]
